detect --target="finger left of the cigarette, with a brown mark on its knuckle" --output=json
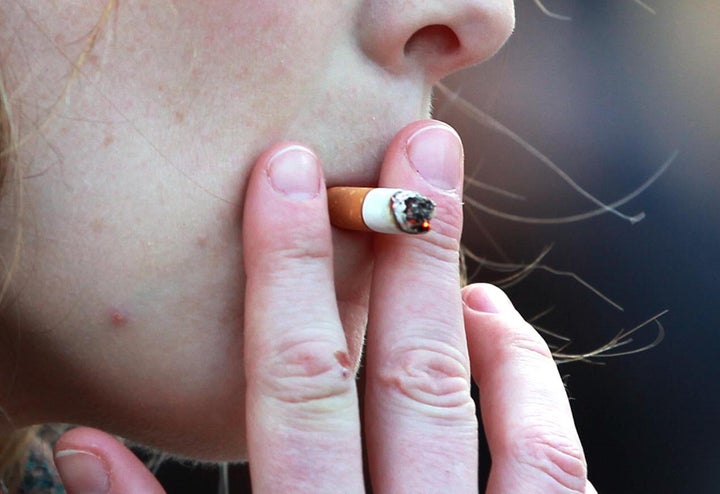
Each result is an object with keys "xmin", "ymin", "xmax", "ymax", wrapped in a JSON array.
[{"xmin": 243, "ymin": 144, "xmax": 363, "ymax": 493}]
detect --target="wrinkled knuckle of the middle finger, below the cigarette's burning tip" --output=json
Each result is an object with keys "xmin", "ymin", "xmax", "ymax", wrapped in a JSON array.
[{"xmin": 378, "ymin": 344, "xmax": 474, "ymax": 417}]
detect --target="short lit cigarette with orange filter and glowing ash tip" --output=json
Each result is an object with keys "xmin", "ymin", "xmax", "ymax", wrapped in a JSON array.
[{"xmin": 328, "ymin": 187, "xmax": 435, "ymax": 234}]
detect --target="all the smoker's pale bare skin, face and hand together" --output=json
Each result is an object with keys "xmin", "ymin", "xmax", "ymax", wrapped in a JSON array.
[{"xmin": 0, "ymin": 0, "xmax": 594, "ymax": 494}]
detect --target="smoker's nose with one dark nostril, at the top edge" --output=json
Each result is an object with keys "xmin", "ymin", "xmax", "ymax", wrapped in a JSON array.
[{"xmin": 358, "ymin": 0, "xmax": 515, "ymax": 83}]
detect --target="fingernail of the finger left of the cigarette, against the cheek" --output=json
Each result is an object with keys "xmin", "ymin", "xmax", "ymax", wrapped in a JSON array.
[{"xmin": 267, "ymin": 146, "xmax": 321, "ymax": 201}]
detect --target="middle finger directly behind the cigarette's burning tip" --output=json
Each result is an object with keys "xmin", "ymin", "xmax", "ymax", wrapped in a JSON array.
[{"xmin": 366, "ymin": 121, "xmax": 478, "ymax": 492}]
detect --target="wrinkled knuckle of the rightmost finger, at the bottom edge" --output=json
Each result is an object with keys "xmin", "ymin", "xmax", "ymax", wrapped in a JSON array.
[{"xmin": 513, "ymin": 428, "xmax": 587, "ymax": 493}]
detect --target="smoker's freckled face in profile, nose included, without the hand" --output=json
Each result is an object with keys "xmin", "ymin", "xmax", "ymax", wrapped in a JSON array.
[{"xmin": 0, "ymin": 0, "xmax": 513, "ymax": 460}]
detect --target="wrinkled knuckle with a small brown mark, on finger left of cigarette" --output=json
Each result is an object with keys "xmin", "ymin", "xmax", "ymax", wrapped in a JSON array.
[{"xmin": 255, "ymin": 341, "xmax": 355, "ymax": 413}]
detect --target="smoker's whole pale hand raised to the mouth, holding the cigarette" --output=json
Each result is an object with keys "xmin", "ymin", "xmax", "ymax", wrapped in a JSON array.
[{"xmin": 56, "ymin": 121, "xmax": 594, "ymax": 494}]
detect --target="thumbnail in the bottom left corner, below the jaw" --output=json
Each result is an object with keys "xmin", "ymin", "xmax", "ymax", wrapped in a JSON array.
[{"xmin": 55, "ymin": 449, "xmax": 110, "ymax": 494}]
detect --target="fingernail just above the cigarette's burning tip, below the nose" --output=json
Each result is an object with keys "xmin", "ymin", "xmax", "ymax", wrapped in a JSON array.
[{"xmin": 407, "ymin": 124, "xmax": 463, "ymax": 191}]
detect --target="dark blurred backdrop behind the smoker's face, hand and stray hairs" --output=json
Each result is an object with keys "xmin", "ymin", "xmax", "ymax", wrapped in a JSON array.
[{"xmin": 153, "ymin": 0, "xmax": 720, "ymax": 494}]
